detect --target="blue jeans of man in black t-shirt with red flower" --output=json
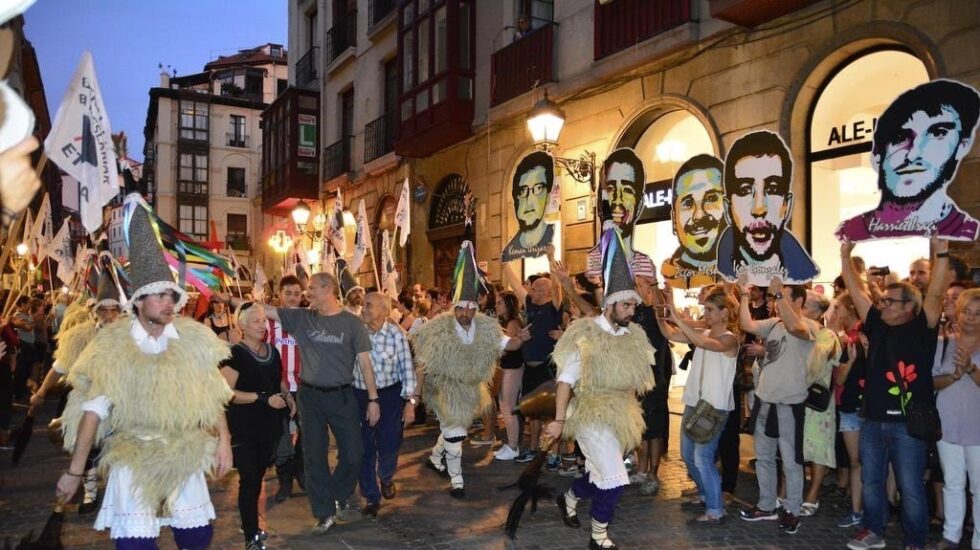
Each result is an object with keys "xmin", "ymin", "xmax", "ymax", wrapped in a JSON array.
[{"xmin": 860, "ymin": 419, "xmax": 929, "ymax": 547}]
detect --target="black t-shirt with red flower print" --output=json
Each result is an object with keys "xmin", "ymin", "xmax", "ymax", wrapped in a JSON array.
[{"xmin": 862, "ymin": 307, "xmax": 939, "ymax": 422}]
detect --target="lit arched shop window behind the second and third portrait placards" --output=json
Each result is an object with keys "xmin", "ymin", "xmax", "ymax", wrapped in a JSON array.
[{"xmin": 619, "ymin": 109, "xmax": 718, "ymax": 280}]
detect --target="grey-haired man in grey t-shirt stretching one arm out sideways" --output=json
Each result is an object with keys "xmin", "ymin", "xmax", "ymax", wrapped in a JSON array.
[{"xmin": 219, "ymin": 273, "xmax": 381, "ymax": 535}]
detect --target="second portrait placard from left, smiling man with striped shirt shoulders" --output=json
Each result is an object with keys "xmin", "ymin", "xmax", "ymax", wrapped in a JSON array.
[{"xmin": 586, "ymin": 147, "xmax": 656, "ymax": 277}]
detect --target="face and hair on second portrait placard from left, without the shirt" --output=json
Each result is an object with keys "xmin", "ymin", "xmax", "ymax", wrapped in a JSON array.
[{"xmin": 599, "ymin": 147, "xmax": 646, "ymax": 241}]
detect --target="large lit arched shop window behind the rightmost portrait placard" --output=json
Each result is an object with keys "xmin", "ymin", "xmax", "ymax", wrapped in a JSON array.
[{"xmin": 807, "ymin": 49, "xmax": 929, "ymax": 281}]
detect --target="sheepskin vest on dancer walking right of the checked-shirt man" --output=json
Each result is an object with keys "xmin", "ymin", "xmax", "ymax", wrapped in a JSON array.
[{"xmin": 412, "ymin": 311, "xmax": 503, "ymax": 427}]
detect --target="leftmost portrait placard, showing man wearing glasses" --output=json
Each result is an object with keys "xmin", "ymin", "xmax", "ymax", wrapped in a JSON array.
[{"xmin": 500, "ymin": 151, "xmax": 555, "ymax": 262}]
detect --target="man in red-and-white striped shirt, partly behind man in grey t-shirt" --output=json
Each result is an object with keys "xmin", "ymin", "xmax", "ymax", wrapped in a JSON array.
[{"xmin": 266, "ymin": 275, "xmax": 306, "ymax": 502}]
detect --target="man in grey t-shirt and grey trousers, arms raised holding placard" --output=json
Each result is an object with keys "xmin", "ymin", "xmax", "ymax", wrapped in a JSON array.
[{"xmin": 738, "ymin": 274, "xmax": 820, "ymax": 534}]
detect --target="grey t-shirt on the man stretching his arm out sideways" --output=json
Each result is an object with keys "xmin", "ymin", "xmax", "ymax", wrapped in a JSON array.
[{"xmin": 276, "ymin": 308, "xmax": 371, "ymax": 387}]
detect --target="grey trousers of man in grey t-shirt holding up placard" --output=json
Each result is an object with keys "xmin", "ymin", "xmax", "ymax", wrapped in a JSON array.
[{"xmin": 754, "ymin": 399, "xmax": 803, "ymax": 516}]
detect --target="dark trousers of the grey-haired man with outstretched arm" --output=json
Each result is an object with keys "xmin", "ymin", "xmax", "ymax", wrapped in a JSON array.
[{"xmin": 296, "ymin": 386, "xmax": 364, "ymax": 519}]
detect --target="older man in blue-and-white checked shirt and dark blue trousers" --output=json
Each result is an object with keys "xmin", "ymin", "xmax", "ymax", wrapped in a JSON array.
[{"xmin": 354, "ymin": 292, "xmax": 419, "ymax": 517}]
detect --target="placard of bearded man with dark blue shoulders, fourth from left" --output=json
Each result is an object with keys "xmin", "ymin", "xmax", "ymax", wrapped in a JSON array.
[{"xmin": 717, "ymin": 131, "xmax": 820, "ymax": 286}]
